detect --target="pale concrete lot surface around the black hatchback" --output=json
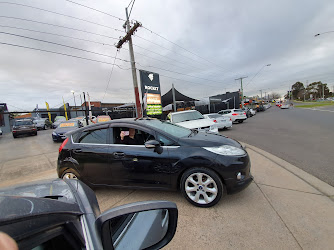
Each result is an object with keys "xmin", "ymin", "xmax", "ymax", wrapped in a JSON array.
[{"xmin": 0, "ymin": 128, "xmax": 334, "ymax": 249}]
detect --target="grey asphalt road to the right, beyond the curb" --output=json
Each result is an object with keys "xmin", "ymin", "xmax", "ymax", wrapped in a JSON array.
[{"xmin": 221, "ymin": 106, "xmax": 334, "ymax": 186}]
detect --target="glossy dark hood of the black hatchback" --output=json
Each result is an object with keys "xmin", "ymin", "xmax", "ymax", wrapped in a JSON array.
[{"xmin": 179, "ymin": 132, "xmax": 242, "ymax": 148}]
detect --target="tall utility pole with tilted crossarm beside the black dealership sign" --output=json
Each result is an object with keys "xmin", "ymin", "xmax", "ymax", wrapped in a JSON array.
[{"xmin": 116, "ymin": 8, "xmax": 143, "ymax": 118}]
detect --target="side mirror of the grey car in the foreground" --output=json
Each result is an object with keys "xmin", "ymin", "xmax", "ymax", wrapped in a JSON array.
[{"xmin": 95, "ymin": 201, "xmax": 178, "ymax": 249}]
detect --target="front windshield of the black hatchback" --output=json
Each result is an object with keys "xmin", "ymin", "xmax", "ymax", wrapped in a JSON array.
[{"xmin": 140, "ymin": 120, "xmax": 191, "ymax": 137}]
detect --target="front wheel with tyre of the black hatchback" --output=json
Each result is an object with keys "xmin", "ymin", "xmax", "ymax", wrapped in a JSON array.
[{"xmin": 180, "ymin": 167, "xmax": 224, "ymax": 207}]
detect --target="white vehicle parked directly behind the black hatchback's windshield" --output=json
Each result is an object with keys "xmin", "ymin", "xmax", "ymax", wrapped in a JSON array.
[{"xmin": 167, "ymin": 110, "xmax": 218, "ymax": 133}]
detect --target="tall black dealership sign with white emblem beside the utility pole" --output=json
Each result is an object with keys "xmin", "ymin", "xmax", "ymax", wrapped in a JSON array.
[{"xmin": 139, "ymin": 70, "xmax": 162, "ymax": 115}]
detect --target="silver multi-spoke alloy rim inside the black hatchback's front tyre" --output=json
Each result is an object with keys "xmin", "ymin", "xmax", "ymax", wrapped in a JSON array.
[{"xmin": 184, "ymin": 173, "xmax": 218, "ymax": 204}]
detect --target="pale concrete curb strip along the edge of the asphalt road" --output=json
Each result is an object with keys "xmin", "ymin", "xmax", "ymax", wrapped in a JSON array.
[{"xmin": 241, "ymin": 142, "xmax": 334, "ymax": 201}]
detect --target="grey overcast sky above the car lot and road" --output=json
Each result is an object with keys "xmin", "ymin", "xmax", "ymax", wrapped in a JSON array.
[{"xmin": 0, "ymin": 0, "xmax": 334, "ymax": 111}]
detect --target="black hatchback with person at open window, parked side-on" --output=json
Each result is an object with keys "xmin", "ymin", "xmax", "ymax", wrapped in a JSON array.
[{"xmin": 57, "ymin": 118, "xmax": 252, "ymax": 207}]
